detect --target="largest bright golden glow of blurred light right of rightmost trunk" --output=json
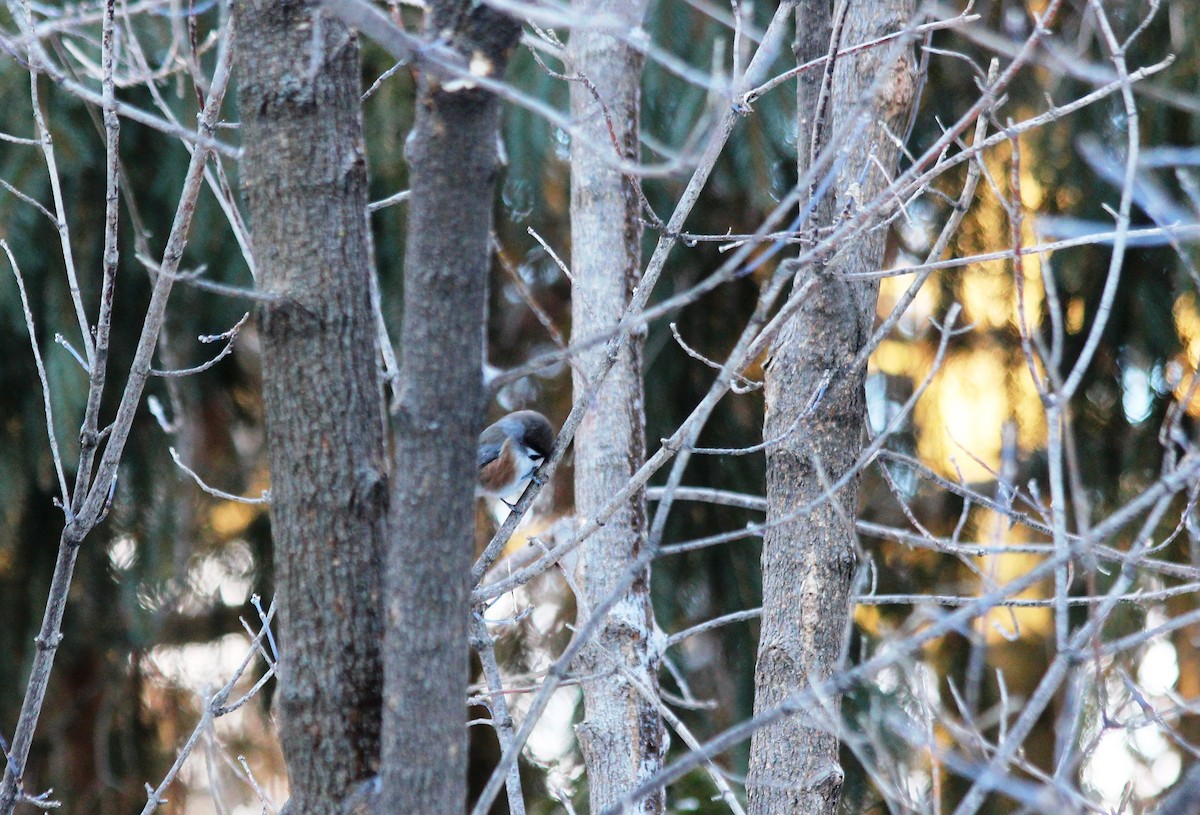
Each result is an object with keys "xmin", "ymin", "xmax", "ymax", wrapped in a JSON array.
[{"xmin": 871, "ymin": 138, "xmax": 1051, "ymax": 481}]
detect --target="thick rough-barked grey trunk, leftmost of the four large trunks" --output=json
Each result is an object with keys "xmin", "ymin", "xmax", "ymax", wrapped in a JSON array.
[{"xmin": 238, "ymin": 0, "xmax": 388, "ymax": 815}]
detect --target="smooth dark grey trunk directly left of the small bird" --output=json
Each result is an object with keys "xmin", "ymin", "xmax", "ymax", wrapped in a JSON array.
[{"xmin": 382, "ymin": 0, "xmax": 521, "ymax": 815}]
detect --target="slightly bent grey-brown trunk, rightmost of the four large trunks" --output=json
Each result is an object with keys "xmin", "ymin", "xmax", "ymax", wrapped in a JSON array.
[{"xmin": 746, "ymin": 0, "xmax": 916, "ymax": 815}]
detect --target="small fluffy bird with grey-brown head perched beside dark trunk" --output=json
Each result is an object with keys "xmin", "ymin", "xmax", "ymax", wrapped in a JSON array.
[{"xmin": 479, "ymin": 411, "xmax": 554, "ymax": 508}]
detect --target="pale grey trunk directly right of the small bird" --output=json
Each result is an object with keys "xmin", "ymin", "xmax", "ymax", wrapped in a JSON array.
[{"xmin": 568, "ymin": 0, "xmax": 667, "ymax": 814}]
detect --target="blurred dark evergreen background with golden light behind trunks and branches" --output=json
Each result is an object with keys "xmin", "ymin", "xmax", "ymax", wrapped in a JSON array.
[{"xmin": 0, "ymin": 0, "xmax": 1200, "ymax": 815}]
